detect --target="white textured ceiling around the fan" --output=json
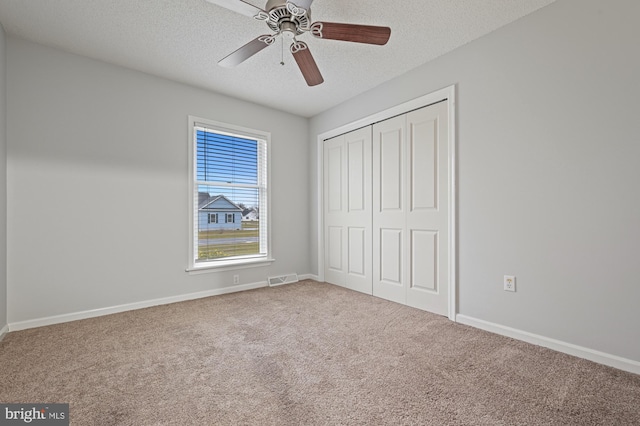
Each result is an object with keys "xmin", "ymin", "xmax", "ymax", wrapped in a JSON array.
[{"xmin": 0, "ymin": 0, "xmax": 555, "ymax": 117}]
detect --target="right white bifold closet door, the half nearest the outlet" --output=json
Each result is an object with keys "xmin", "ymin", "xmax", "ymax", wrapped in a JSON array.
[{"xmin": 372, "ymin": 101, "xmax": 451, "ymax": 315}]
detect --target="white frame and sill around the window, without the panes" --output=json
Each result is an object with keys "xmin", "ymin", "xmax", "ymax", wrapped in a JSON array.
[{"xmin": 186, "ymin": 115, "xmax": 275, "ymax": 274}]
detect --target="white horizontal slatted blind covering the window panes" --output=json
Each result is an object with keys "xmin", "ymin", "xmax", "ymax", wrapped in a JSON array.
[{"xmin": 194, "ymin": 125, "xmax": 268, "ymax": 262}]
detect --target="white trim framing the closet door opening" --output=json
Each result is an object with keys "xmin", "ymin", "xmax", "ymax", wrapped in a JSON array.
[{"xmin": 316, "ymin": 85, "xmax": 458, "ymax": 321}]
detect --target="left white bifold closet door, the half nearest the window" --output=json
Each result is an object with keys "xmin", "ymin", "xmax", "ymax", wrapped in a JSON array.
[{"xmin": 323, "ymin": 126, "xmax": 372, "ymax": 294}]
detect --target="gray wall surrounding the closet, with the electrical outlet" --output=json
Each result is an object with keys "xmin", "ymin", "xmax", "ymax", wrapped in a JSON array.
[{"xmin": 310, "ymin": 0, "xmax": 640, "ymax": 361}]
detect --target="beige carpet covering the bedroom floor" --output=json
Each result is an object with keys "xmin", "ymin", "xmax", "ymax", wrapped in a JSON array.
[{"xmin": 0, "ymin": 281, "xmax": 640, "ymax": 426}]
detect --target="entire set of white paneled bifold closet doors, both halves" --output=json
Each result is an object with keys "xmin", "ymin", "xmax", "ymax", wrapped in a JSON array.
[{"xmin": 323, "ymin": 100, "xmax": 452, "ymax": 315}]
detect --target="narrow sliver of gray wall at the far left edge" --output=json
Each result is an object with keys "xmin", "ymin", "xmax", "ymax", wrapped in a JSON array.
[{"xmin": 0, "ymin": 25, "xmax": 7, "ymax": 330}]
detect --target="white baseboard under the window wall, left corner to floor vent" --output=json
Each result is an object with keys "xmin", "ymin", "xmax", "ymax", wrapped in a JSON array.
[{"xmin": 10, "ymin": 281, "xmax": 267, "ymax": 331}]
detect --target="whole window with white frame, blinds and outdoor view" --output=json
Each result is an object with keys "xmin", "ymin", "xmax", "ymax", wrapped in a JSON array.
[{"xmin": 188, "ymin": 117, "xmax": 272, "ymax": 271}]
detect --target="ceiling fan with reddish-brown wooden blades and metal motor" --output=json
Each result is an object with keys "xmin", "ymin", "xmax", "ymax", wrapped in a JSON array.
[{"xmin": 207, "ymin": 0, "xmax": 391, "ymax": 86}]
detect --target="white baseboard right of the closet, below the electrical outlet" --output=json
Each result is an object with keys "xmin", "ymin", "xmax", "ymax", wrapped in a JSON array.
[{"xmin": 456, "ymin": 314, "xmax": 640, "ymax": 374}]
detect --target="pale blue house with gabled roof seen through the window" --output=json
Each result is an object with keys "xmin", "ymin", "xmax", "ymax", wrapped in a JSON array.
[{"xmin": 198, "ymin": 192, "xmax": 242, "ymax": 231}]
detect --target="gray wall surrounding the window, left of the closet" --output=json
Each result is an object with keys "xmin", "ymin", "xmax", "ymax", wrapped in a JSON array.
[{"xmin": 3, "ymin": 37, "xmax": 309, "ymax": 324}]
